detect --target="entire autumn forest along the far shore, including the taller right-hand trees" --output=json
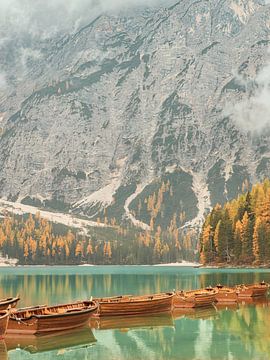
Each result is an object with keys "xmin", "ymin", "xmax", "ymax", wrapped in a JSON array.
[{"xmin": 4, "ymin": 180, "xmax": 270, "ymax": 265}]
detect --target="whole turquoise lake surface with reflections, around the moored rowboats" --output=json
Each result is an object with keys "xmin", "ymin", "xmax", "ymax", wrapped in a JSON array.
[{"xmin": 0, "ymin": 266, "xmax": 270, "ymax": 360}]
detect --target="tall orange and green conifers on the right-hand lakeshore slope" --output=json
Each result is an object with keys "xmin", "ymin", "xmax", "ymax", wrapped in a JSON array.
[{"xmin": 200, "ymin": 180, "xmax": 270, "ymax": 265}]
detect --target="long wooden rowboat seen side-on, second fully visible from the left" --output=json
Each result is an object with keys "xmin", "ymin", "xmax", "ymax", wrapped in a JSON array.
[{"xmin": 94, "ymin": 293, "xmax": 174, "ymax": 316}]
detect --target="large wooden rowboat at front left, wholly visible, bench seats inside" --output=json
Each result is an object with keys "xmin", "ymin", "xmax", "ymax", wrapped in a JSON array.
[{"xmin": 7, "ymin": 301, "xmax": 97, "ymax": 334}]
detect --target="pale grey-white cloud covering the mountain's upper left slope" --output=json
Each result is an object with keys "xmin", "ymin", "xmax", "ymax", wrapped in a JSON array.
[{"xmin": 0, "ymin": 0, "xmax": 171, "ymax": 90}]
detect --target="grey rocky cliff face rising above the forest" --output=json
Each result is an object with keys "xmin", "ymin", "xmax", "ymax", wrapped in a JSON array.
[{"xmin": 0, "ymin": 0, "xmax": 270, "ymax": 228}]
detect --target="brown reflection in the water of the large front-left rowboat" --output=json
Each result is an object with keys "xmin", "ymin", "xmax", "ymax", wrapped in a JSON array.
[{"xmin": 5, "ymin": 327, "xmax": 97, "ymax": 359}]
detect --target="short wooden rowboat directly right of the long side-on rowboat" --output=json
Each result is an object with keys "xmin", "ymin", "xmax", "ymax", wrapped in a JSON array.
[{"xmin": 173, "ymin": 288, "xmax": 217, "ymax": 308}]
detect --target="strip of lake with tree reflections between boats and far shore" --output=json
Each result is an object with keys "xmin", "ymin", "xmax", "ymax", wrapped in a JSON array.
[{"xmin": 0, "ymin": 267, "xmax": 270, "ymax": 306}]
